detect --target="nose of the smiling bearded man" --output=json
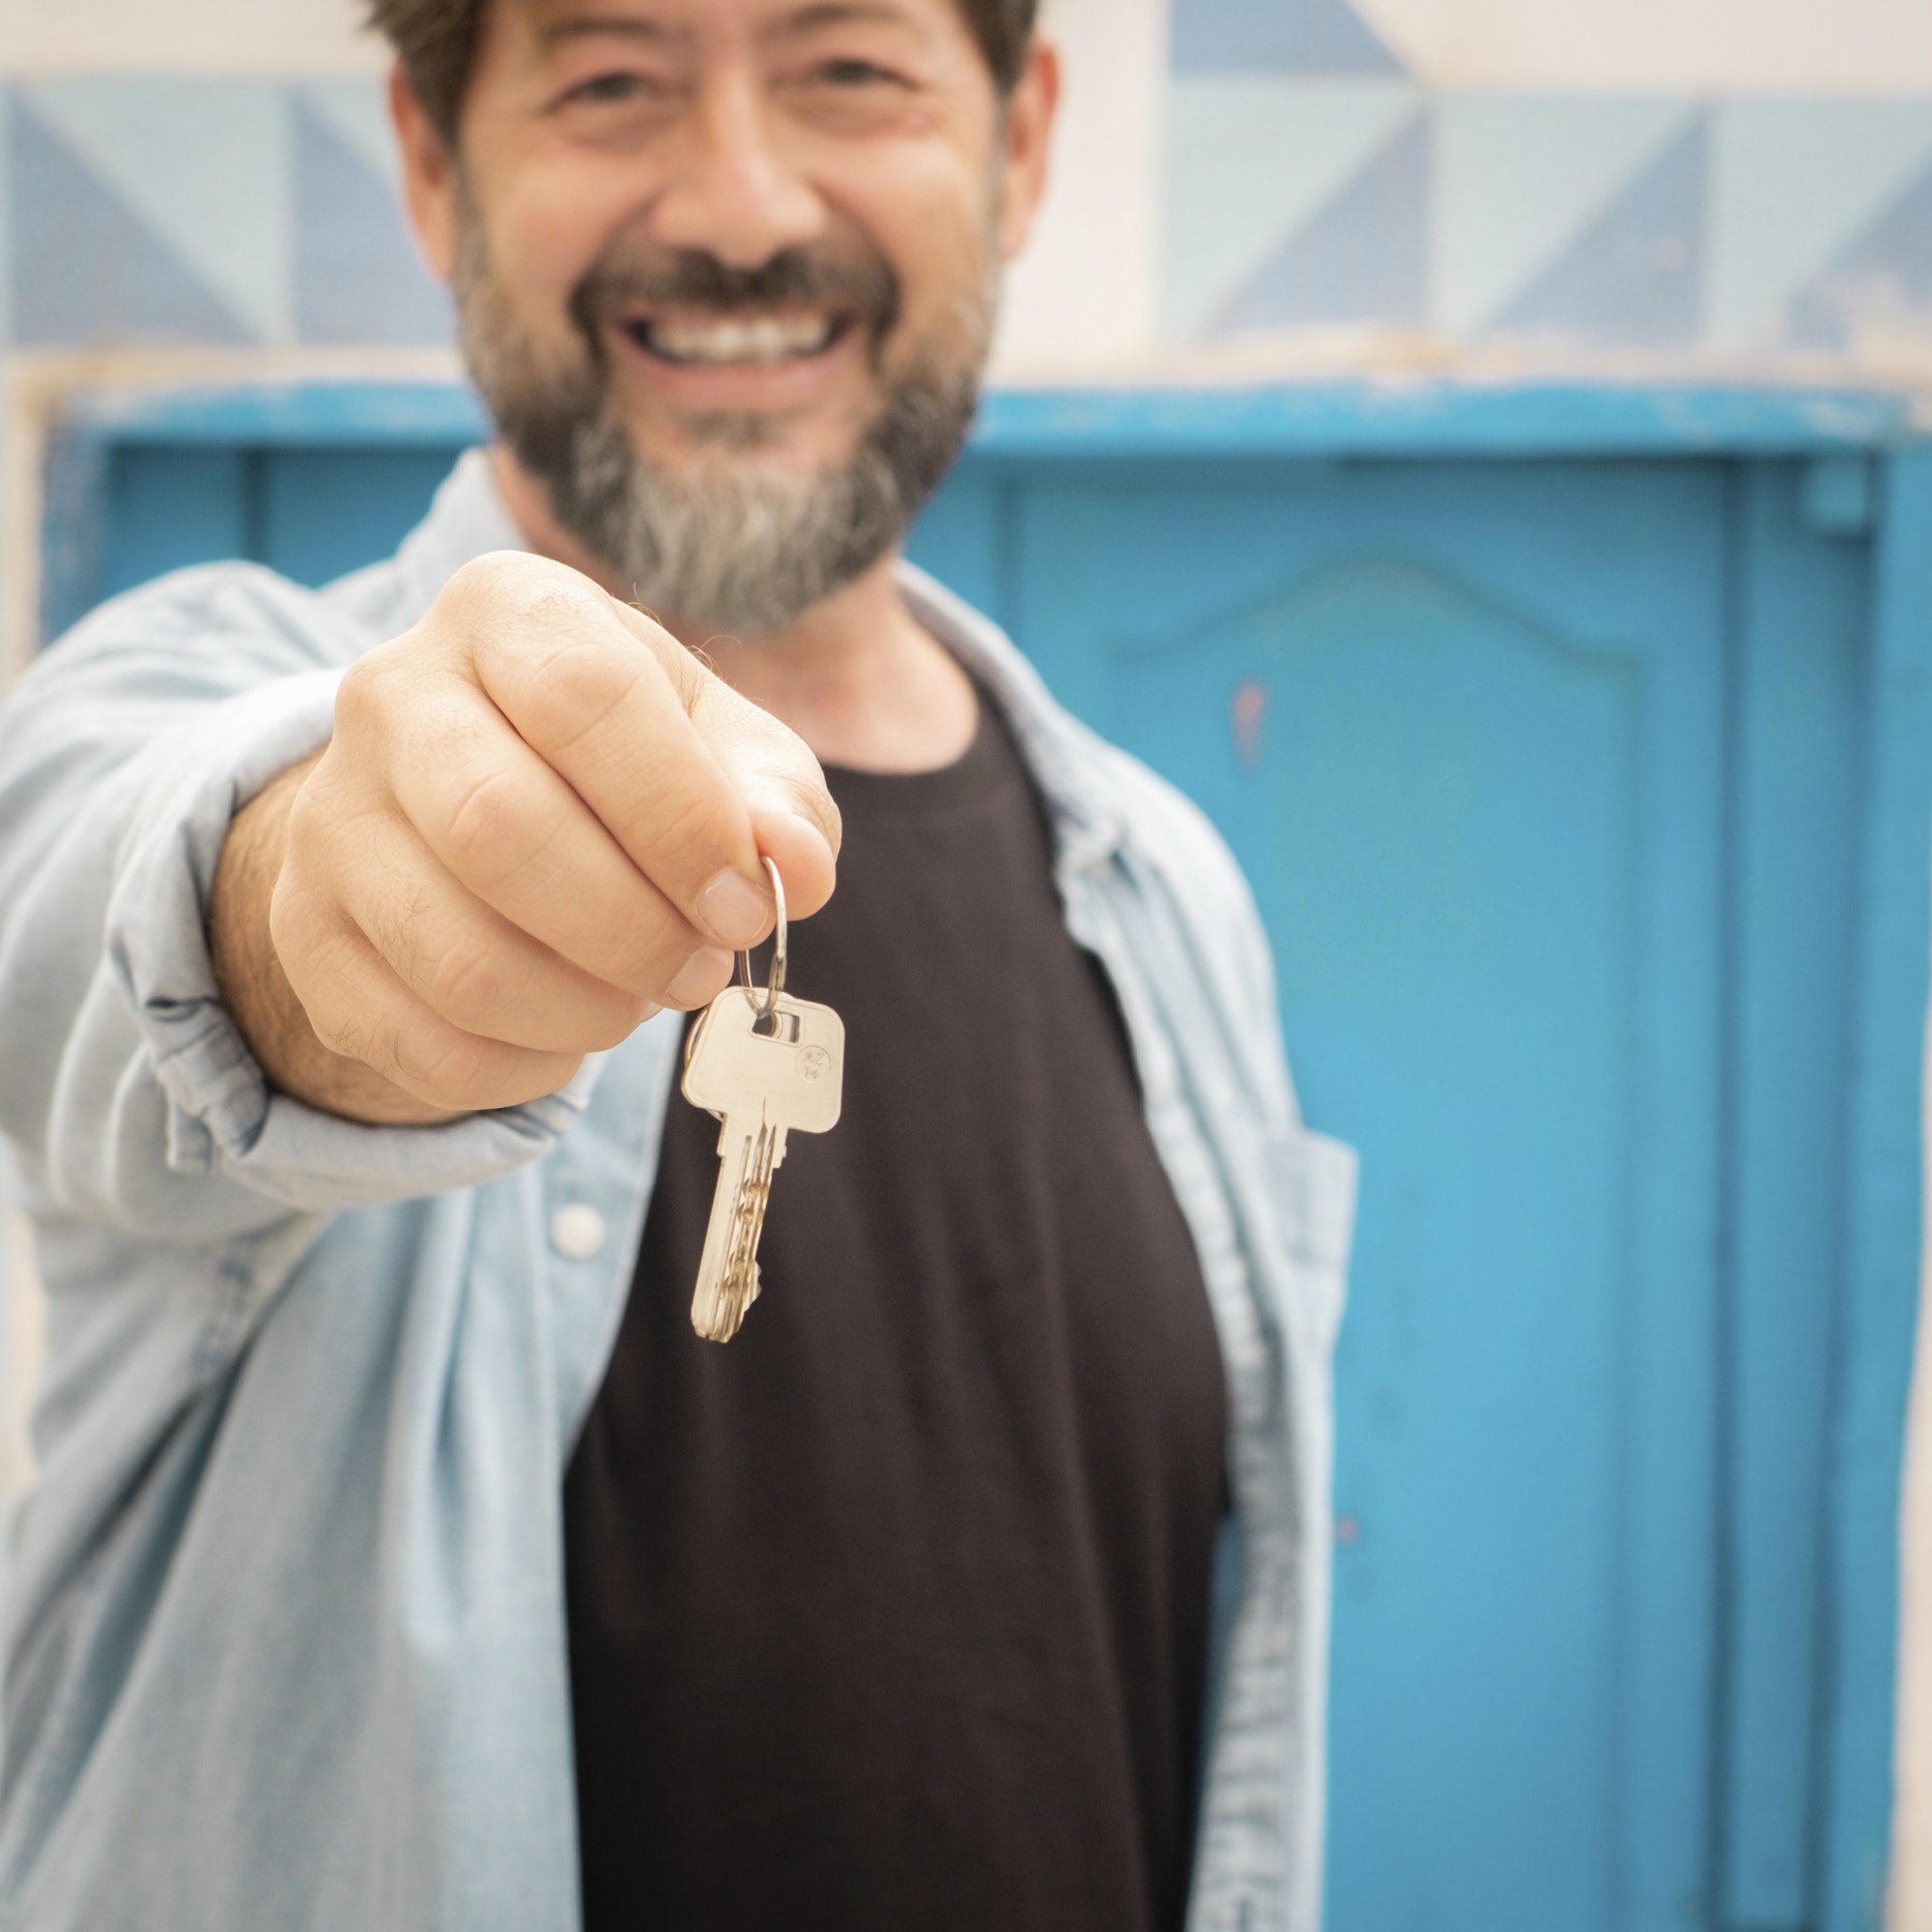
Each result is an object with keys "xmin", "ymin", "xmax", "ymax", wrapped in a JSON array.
[{"xmin": 651, "ymin": 75, "xmax": 825, "ymax": 269}]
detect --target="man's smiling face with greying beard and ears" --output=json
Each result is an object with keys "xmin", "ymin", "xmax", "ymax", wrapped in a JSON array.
[{"xmin": 396, "ymin": 0, "xmax": 1055, "ymax": 636}]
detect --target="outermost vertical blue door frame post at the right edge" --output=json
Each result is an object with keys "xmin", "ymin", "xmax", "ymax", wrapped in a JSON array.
[{"xmin": 1818, "ymin": 450, "xmax": 1932, "ymax": 1932}]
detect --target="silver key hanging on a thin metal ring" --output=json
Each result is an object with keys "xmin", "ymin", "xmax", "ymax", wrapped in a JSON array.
[{"xmin": 684, "ymin": 860, "xmax": 844, "ymax": 1341}]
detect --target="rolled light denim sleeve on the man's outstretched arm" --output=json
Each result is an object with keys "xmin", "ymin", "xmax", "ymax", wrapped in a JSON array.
[{"xmin": 0, "ymin": 564, "xmax": 597, "ymax": 1240}]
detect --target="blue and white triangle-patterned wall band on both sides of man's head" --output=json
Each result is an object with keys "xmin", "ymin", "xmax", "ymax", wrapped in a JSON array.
[{"xmin": 0, "ymin": 0, "xmax": 1932, "ymax": 371}]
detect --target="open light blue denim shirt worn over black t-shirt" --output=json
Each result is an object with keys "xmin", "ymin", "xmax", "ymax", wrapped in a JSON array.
[{"xmin": 0, "ymin": 456, "xmax": 1354, "ymax": 1932}]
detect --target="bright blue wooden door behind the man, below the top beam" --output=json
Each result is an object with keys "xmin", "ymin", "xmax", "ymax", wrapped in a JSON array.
[{"xmin": 38, "ymin": 398, "xmax": 1932, "ymax": 1932}]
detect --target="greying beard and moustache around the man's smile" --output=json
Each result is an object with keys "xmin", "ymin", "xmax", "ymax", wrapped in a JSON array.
[{"xmin": 452, "ymin": 195, "xmax": 997, "ymax": 638}]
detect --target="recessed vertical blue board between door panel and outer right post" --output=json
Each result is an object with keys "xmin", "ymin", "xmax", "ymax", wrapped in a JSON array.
[{"xmin": 1719, "ymin": 464, "xmax": 1872, "ymax": 1928}]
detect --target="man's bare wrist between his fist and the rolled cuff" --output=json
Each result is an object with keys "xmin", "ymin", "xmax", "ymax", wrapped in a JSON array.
[{"xmin": 209, "ymin": 752, "xmax": 452, "ymax": 1126}]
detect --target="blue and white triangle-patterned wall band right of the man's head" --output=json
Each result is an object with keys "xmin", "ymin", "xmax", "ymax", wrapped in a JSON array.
[{"xmin": 1163, "ymin": 0, "xmax": 1932, "ymax": 367}]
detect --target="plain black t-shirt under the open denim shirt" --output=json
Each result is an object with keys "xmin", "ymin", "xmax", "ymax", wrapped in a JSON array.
[{"xmin": 564, "ymin": 703, "xmax": 1225, "ymax": 1932}]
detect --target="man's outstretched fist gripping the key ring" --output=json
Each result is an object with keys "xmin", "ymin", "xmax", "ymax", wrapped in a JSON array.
[{"xmin": 282, "ymin": 556, "xmax": 840, "ymax": 1111}]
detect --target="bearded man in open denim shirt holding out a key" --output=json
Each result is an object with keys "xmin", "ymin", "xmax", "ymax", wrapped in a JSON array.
[{"xmin": 0, "ymin": 0, "xmax": 1350, "ymax": 1932}]
